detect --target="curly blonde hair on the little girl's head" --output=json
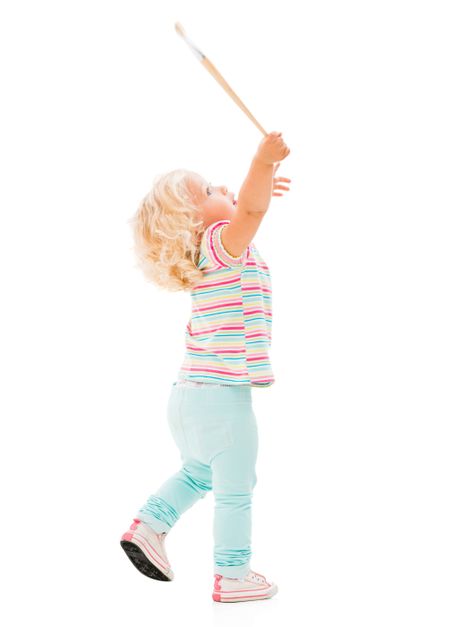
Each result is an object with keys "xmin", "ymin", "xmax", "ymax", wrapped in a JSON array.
[{"xmin": 128, "ymin": 168, "xmax": 205, "ymax": 292}]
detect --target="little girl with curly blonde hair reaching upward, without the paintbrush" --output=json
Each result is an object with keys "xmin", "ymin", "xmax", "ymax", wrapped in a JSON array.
[{"xmin": 120, "ymin": 132, "xmax": 290, "ymax": 602}]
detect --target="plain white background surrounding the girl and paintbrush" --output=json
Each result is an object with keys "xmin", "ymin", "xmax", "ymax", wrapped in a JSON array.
[{"xmin": 0, "ymin": 0, "xmax": 450, "ymax": 627}]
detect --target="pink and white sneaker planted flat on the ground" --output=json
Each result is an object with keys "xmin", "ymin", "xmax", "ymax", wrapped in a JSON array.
[{"xmin": 212, "ymin": 570, "xmax": 278, "ymax": 603}]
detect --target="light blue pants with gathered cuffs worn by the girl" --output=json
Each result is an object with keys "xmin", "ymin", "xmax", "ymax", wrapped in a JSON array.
[{"xmin": 136, "ymin": 383, "xmax": 258, "ymax": 578}]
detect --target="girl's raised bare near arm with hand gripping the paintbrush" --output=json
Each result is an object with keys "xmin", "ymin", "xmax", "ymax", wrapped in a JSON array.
[{"xmin": 222, "ymin": 131, "xmax": 290, "ymax": 257}]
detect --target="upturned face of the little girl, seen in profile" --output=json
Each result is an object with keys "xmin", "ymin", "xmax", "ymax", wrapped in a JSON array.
[{"xmin": 188, "ymin": 172, "xmax": 235, "ymax": 228}]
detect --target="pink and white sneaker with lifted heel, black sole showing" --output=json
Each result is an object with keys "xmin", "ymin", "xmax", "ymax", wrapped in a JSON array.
[{"xmin": 120, "ymin": 518, "xmax": 174, "ymax": 581}]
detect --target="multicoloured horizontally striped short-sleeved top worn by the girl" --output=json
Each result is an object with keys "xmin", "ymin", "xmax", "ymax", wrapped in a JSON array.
[{"xmin": 178, "ymin": 220, "xmax": 275, "ymax": 387}]
